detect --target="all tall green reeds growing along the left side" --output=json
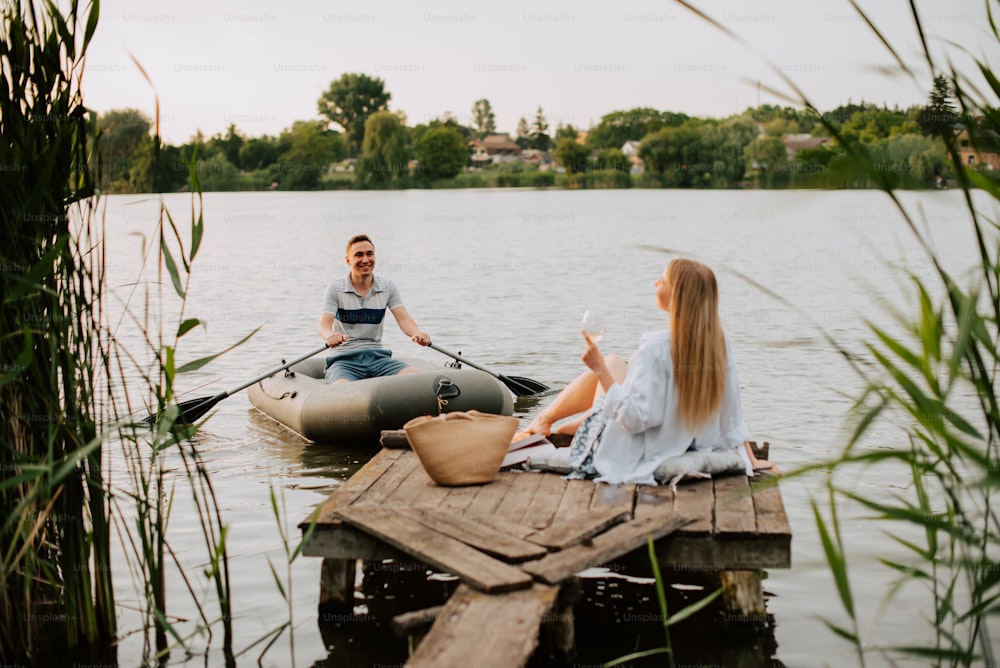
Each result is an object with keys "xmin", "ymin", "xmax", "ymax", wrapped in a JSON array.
[{"xmin": 0, "ymin": 0, "xmax": 244, "ymax": 665}]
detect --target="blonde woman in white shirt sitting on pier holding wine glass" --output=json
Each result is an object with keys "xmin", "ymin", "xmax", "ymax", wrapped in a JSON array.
[{"xmin": 516, "ymin": 259, "xmax": 777, "ymax": 484}]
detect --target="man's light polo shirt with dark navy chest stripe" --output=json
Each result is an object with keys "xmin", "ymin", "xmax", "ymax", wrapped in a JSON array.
[{"xmin": 322, "ymin": 274, "xmax": 403, "ymax": 357}]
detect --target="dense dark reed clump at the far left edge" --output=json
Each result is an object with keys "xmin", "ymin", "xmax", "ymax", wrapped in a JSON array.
[{"xmin": 0, "ymin": 0, "xmax": 115, "ymax": 662}]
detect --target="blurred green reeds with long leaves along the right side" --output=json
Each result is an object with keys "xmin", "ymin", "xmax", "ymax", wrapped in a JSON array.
[{"xmin": 678, "ymin": 0, "xmax": 1000, "ymax": 666}]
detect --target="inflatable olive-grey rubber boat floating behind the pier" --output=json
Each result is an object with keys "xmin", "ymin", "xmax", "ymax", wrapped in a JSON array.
[{"xmin": 247, "ymin": 357, "xmax": 514, "ymax": 444}]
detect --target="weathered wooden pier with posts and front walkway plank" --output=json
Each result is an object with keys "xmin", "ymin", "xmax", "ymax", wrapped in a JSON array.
[{"xmin": 300, "ymin": 436, "xmax": 791, "ymax": 666}]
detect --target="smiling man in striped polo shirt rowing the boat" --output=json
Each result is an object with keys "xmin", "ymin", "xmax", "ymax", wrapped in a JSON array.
[{"xmin": 318, "ymin": 234, "xmax": 431, "ymax": 383}]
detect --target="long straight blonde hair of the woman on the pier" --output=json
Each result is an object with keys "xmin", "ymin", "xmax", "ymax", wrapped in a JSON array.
[{"xmin": 667, "ymin": 259, "xmax": 727, "ymax": 429}]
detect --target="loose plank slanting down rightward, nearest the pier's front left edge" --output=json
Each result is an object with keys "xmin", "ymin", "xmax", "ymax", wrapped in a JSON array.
[{"xmin": 336, "ymin": 504, "xmax": 531, "ymax": 592}]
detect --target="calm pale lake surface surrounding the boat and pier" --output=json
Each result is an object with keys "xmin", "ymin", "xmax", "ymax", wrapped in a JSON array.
[{"xmin": 104, "ymin": 190, "xmax": 996, "ymax": 666}]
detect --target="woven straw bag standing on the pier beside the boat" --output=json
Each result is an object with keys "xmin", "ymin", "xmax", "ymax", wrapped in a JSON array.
[{"xmin": 403, "ymin": 411, "xmax": 518, "ymax": 486}]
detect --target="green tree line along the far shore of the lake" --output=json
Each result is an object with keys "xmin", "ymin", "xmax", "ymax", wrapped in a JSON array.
[{"xmin": 97, "ymin": 73, "xmax": 980, "ymax": 192}]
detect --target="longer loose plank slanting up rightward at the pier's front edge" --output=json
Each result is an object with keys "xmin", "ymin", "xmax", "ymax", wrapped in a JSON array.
[{"xmin": 521, "ymin": 516, "xmax": 685, "ymax": 584}]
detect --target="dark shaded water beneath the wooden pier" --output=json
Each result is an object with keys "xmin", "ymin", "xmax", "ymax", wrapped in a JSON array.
[{"xmin": 304, "ymin": 559, "xmax": 783, "ymax": 668}]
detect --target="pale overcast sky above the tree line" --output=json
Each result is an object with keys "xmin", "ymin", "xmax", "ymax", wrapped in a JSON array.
[{"xmin": 84, "ymin": 0, "xmax": 1000, "ymax": 144}]
